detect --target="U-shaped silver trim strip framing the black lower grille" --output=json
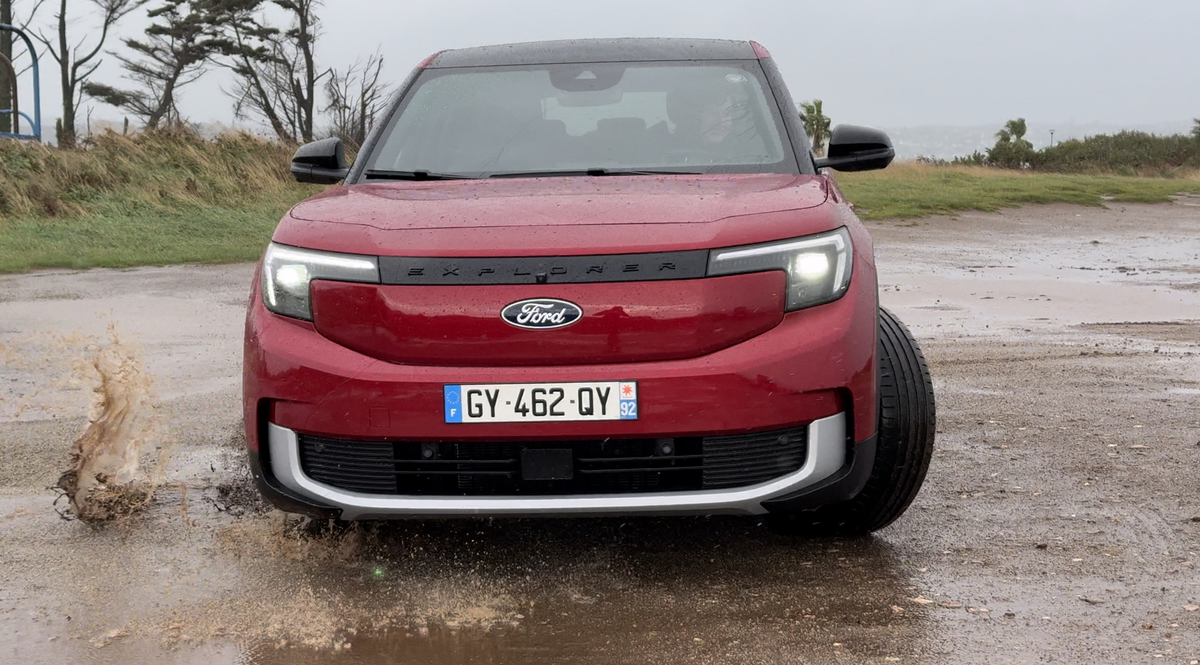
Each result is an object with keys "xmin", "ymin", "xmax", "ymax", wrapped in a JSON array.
[{"xmin": 268, "ymin": 413, "xmax": 846, "ymax": 520}]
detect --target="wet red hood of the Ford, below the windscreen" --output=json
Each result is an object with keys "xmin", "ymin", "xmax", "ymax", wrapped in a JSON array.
[{"xmin": 274, "ymin": 174, "xmax": 839, "ymax": 257}]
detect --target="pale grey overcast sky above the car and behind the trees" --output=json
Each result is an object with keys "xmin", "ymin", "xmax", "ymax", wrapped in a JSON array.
[{"xmin": 17, "ymin": 0, "xmax": 1200, "ymax": 136}]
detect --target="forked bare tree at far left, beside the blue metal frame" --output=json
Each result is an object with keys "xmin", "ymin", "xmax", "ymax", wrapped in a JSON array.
[{"xmin": 37, "ymin": 0, "xmax": 150, "ymax": 148}]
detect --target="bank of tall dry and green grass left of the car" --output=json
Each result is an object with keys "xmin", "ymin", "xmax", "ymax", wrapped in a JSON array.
[{"xmin": 0, "ymin": 132, "xmax": 320, "ymax": 272}]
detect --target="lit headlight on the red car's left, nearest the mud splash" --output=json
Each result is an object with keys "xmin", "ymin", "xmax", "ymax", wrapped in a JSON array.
[{"xmin": 263, "ymin": 242, "xmax": 379, "ymax": 320}]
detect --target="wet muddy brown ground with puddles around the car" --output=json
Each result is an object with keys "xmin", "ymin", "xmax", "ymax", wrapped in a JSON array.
[{"xmin": 0, "ymin": 199, "xmax": 1200, "ymax": 665}]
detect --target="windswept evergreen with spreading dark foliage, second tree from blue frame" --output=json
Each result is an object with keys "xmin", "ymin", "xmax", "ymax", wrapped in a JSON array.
[{"xmin": 83, "ymin": 0, "xmax": 217, "ymax": 130}]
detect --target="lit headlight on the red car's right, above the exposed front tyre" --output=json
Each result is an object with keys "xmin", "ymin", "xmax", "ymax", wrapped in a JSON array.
[{"xmin": 708, "ymin": 227, "xmax": 853, "ymax": 312}]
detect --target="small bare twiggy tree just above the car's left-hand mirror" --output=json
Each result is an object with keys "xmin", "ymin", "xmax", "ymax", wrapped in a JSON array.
[{"xmin": 323, "ymin": 53, "xmax": 388, "ymax": 150}]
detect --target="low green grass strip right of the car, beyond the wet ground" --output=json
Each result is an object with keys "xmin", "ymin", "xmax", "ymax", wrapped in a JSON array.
[{"xmin": 836, "ymin": 162, "xmax": 1200, "ymax": 220}]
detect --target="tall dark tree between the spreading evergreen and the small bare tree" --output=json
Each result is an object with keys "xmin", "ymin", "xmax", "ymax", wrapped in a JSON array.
[{"xmin": 210, "ymin": 0, "xmax": 329, "ymax": 143}]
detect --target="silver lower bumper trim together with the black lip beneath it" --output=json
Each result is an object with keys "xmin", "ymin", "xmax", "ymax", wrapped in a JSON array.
[{"xmin": 256, "ymin": 413, "xmax": 874, "ymax": 520}]
